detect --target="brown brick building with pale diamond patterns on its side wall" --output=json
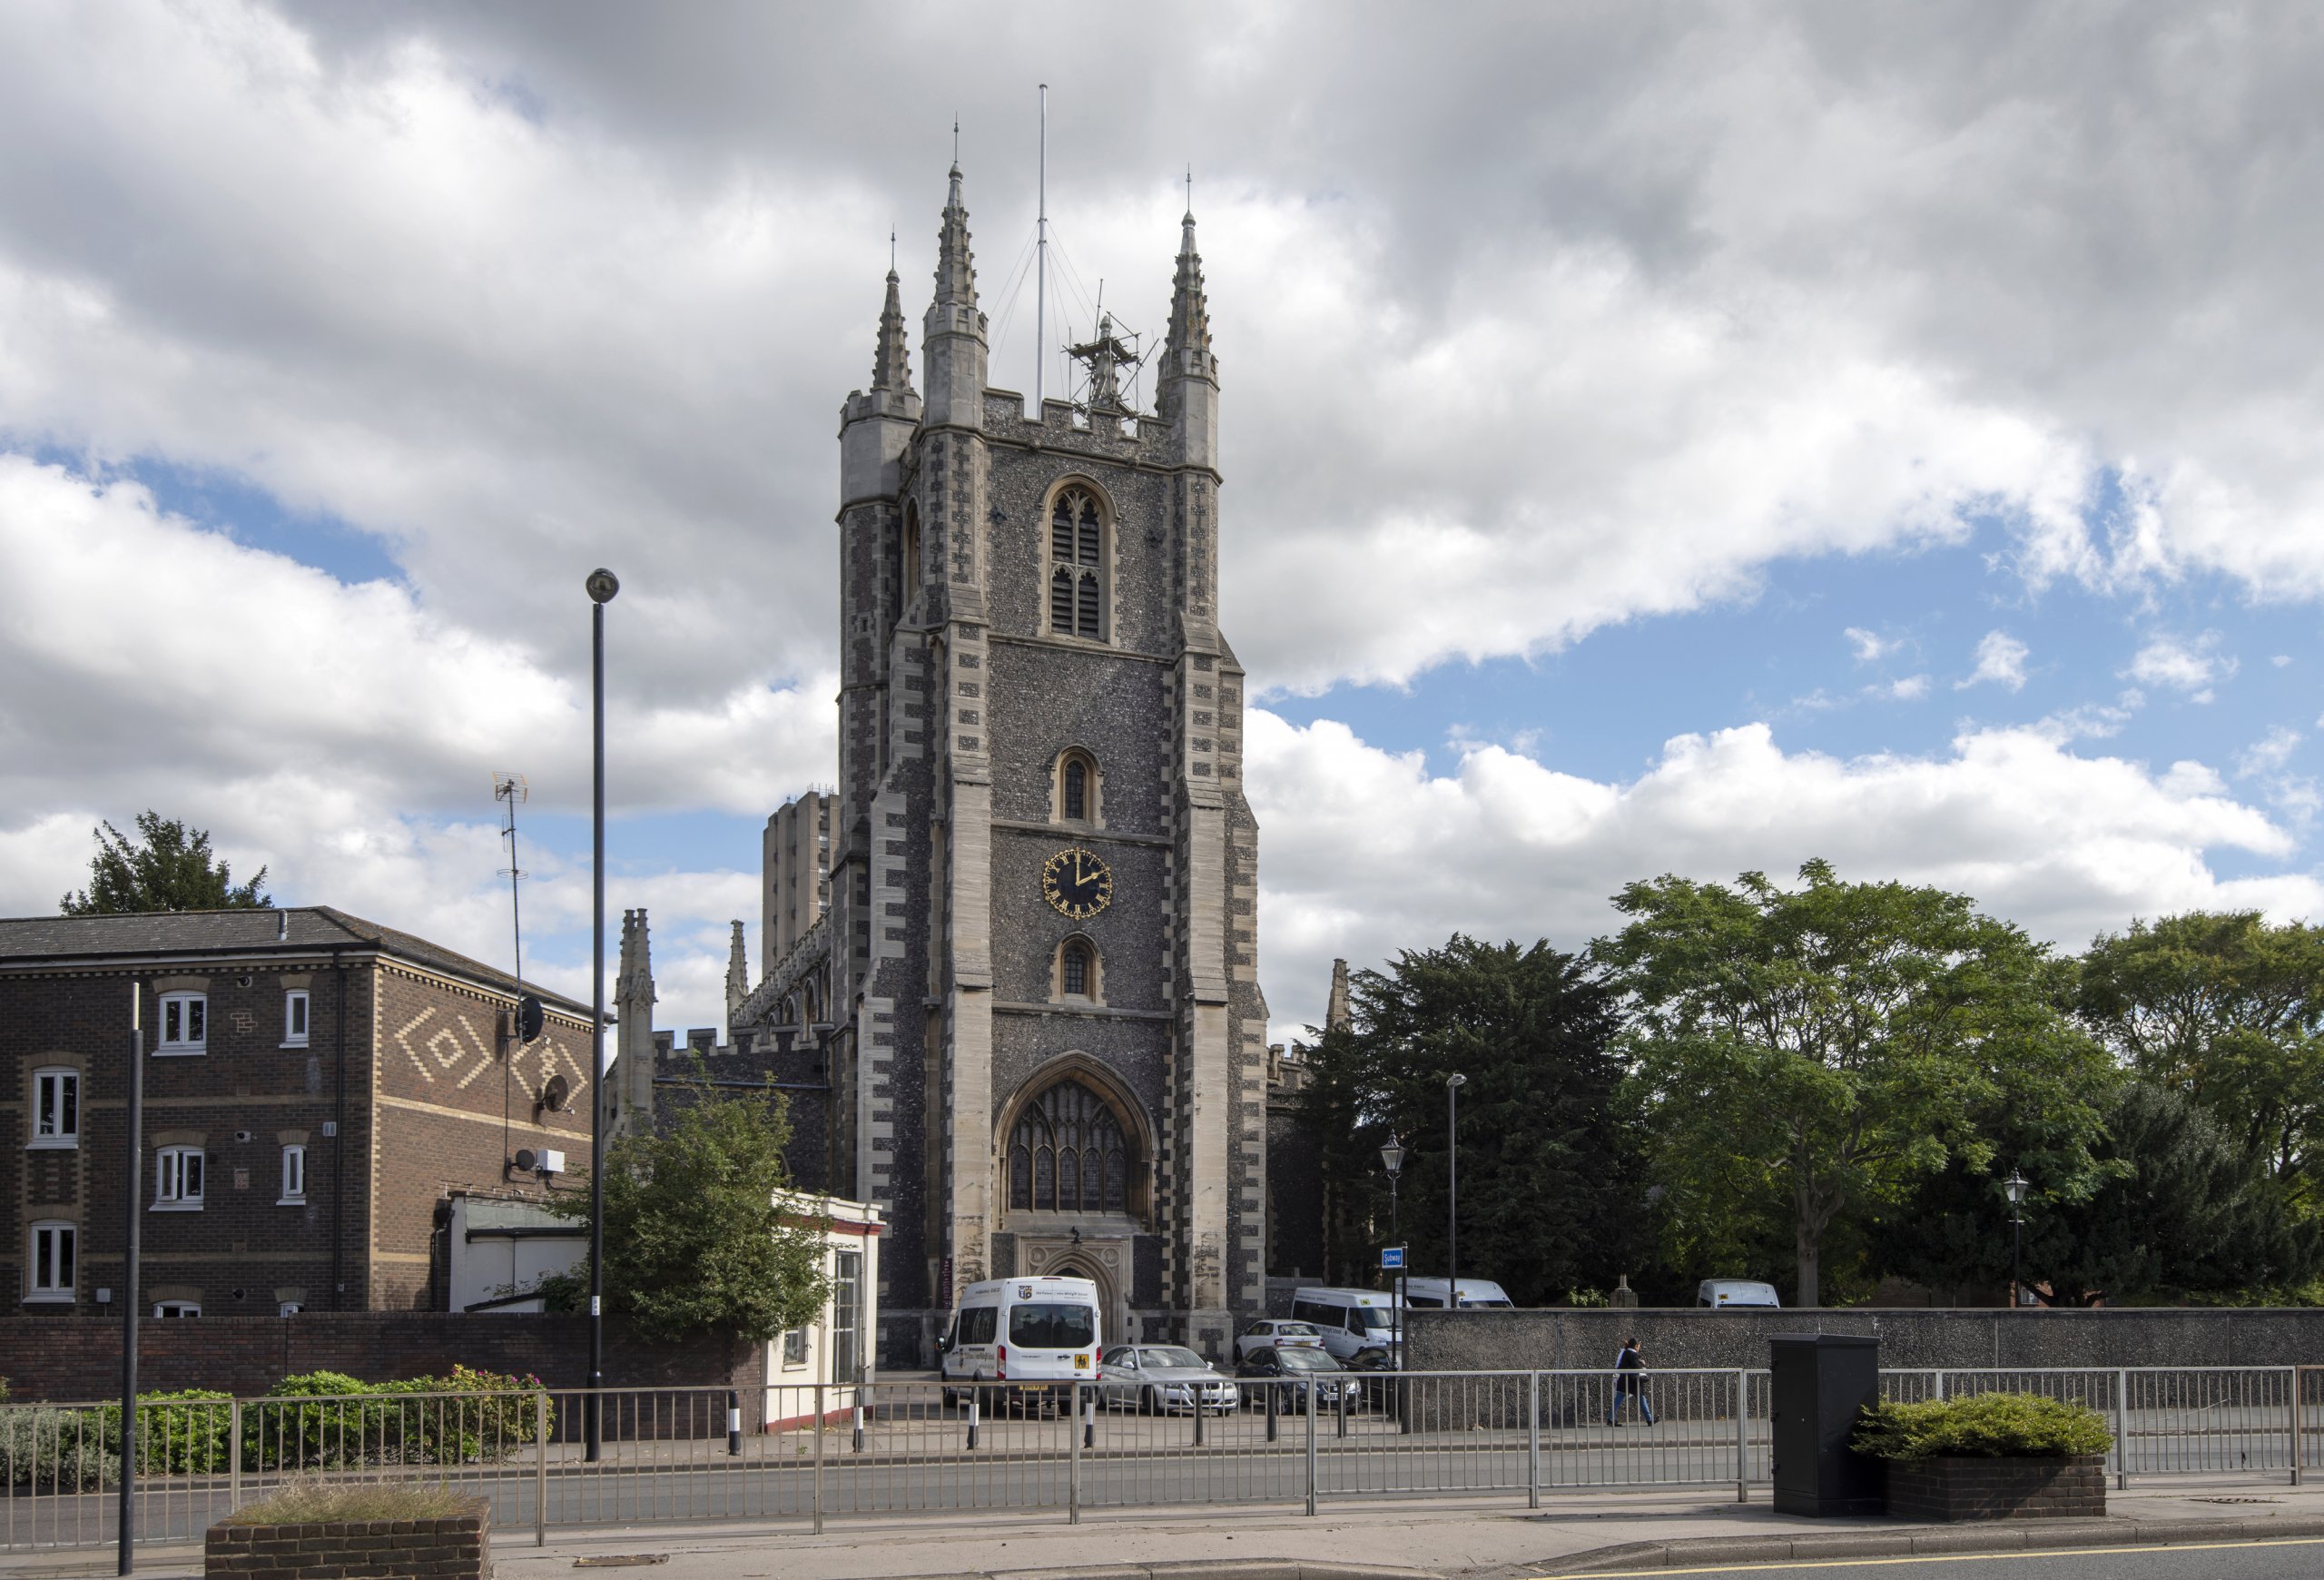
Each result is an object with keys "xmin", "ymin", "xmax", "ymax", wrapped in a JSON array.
[{"xmin": 0, "ymin": 906, "xmax": 593, "ymax": 1318}]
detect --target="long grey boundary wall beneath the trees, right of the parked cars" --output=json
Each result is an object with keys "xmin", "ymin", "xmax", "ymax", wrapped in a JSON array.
[{"xmin": 1403, "ymin": 1306, "xmax": 2324, "ymax": 1371}]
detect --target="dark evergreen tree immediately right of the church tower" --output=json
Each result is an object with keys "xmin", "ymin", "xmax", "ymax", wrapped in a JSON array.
[{"xmin": 1304, "ymin": 934, "xmax": 1643, "ymax": 1306}]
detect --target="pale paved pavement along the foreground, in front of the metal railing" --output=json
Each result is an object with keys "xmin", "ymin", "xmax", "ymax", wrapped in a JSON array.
[{"xmin": 14, "ymin": 1477, "xmax": 2324, "ymax": 1580}]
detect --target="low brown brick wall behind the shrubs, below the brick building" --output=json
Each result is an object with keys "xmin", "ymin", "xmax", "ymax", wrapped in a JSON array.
[{"xmin": 0, "ymin": 1310, "xmax": 764, "ymax": 1404}]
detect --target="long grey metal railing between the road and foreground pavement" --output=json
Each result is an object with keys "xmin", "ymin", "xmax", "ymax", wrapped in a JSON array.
[{"xmin": 0, "ymin": 1367, "xmax": 2324, "ymax": 1550}]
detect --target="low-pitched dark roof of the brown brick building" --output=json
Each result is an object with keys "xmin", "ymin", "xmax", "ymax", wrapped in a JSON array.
[{"xmin": 0, "ymin": 906, "xmax": 590, "ymax": 1020}]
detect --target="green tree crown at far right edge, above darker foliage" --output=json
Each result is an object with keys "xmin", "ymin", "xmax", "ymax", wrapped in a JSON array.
[{"xmin": 2080, "ymin": 911, "xmax": 2324, "ymax": 1215}]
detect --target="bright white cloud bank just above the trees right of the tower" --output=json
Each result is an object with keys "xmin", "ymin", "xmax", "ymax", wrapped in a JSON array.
[{"xmin": 1248, "ymin": 708, "xmax": 2324, "ymax": 1039}]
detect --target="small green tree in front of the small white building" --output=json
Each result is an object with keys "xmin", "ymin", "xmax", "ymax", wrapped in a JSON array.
[{"xmin": 547, "ymin": 1064, "xmax": 830, "ymax": 1343}]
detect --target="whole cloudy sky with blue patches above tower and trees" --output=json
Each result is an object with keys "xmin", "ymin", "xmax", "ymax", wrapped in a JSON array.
[{"xmin": 0, "ymin": 0, "xmax": 2324, "ymax": 1036}]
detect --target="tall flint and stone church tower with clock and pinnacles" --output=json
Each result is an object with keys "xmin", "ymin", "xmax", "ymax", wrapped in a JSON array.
[{"xmin": 803, "ymin": 165, "xmax": 1266, "ymax": 1364}]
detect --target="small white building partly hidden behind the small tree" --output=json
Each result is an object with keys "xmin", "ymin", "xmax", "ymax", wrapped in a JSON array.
[{"xmin": 447, "ymin": 1194, "xmax": 885, "ymax": 1429}]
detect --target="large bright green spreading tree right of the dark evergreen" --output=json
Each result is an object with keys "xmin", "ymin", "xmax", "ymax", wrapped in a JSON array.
[{"xmin": 1594, "ymin": 860, "xmax": 2108, "ymax": 1306}]
